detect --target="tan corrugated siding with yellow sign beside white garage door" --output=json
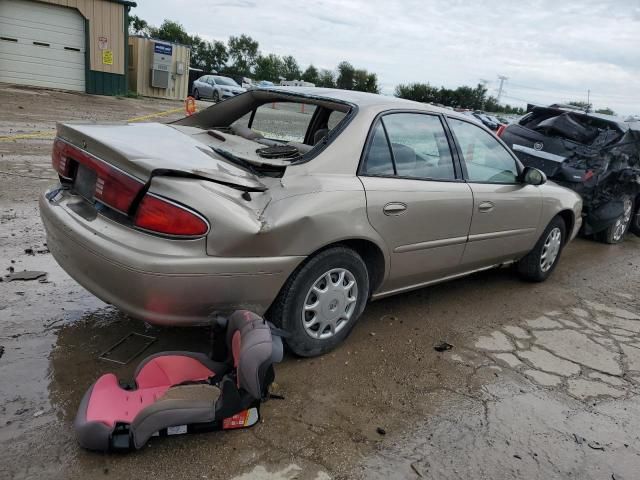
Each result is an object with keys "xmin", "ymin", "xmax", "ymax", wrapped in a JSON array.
[{"xmin": 40, "ymin": 0, "xmax": 127, "ymax": 75}]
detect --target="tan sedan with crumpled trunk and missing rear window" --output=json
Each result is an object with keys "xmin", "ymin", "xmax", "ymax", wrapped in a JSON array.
[{"xmin": 40, "ymin": 87, "xmax": 582, "ymax": 356}]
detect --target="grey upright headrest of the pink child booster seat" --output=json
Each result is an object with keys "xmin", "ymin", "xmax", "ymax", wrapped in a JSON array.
[{"xmin": 227, "ymin": 310, "xmax": 283, "ymax": 399}]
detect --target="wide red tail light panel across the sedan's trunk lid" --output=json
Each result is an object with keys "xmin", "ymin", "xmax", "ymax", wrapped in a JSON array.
[{"xmin": 52, "ymin": 138, "xmax": 144, "ymax": 214}]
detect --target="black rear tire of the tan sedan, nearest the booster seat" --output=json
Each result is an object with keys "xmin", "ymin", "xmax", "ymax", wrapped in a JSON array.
[{"xmin": 268, "ymin": 247, "xmax": 369, "ymax": 357}]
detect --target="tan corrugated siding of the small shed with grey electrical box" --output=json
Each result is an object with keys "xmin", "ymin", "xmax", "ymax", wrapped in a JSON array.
[{"xmin": 129, "ymin": 37, "xmax": 191, "ymax": 100}]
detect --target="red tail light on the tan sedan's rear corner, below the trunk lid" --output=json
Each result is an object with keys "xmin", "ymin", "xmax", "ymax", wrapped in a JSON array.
[{"xmin": 134, "ymin": 194, "xmax": 209, "ymax": 237}]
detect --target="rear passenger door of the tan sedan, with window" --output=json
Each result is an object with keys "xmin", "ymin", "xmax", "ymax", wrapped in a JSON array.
[{"xmin": 359, "ymin": 112, "xmax": 473, "ymax": 292}]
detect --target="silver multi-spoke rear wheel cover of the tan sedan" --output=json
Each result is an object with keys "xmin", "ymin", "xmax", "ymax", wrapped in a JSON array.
[{"xmin": 302, "ymin": 268, "xmax": 358, "ymax": 340}]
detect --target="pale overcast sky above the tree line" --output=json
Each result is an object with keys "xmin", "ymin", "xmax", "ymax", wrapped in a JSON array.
[{"xmin": 132, "ymin": 0, "xmax": 640, "ymax": 114}]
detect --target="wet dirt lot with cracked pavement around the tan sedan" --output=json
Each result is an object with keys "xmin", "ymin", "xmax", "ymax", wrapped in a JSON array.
[{"xmin": 0, "ymin": 87, "xmax": 640, "ymax": 480}]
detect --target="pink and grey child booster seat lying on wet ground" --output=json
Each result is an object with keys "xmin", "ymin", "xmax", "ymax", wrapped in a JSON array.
[{"xmin": 74, "ymin": 310, "xmax": 283, "ymax": 451}]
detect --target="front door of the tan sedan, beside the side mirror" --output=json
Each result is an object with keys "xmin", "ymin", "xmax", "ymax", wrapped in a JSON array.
[{"xmin": 447, "ymin": 118, "xmax": 542, "ymax": 270}]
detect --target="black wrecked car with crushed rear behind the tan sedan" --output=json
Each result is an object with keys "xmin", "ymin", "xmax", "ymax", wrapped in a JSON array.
[{"xmin": 498, "ymin": 105, "xmax": 640, "ymax": 243}]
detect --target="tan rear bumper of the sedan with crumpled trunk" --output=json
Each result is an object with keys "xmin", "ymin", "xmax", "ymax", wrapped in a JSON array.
[{"xmin": 39, "ymin": 190, "xmax": 304, "ymax": 325}]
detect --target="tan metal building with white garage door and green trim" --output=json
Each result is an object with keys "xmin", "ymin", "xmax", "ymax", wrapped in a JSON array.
[{"xmin": 0, "ymin": 0, "xmax": 136, "ymax": 95}]
